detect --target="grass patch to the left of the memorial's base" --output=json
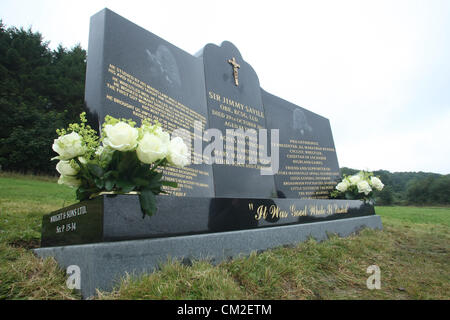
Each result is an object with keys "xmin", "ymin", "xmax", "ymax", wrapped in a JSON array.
[{"xmin": 0, "ymin": 173, "xmax": 79, "ymax": 299}]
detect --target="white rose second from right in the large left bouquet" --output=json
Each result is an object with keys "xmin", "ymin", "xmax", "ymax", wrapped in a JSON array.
[{"xmin": 136, "ymin": 133, "xmax": 169, "ymax": 164}]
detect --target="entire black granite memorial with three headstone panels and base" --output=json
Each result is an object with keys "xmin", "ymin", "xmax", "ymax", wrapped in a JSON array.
[{"xmin": 35, "ymin": 9, "xmax": 381, "ymax": 296}]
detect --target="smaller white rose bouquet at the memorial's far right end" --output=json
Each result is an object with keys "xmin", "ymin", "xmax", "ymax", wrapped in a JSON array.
[{"xmin": 331, "ymin": 171, "xmax": 384, "ymax": 202}]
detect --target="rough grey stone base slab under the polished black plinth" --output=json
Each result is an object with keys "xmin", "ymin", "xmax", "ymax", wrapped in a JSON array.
[{"xmin": 34, "ymin": 215, "xmax": 382, "ymax": 298}]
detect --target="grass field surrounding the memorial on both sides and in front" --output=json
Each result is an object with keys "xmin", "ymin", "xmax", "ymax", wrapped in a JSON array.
[{"xmin": 0, "ymin": 173, "xmax": 450, "ymax": 299}]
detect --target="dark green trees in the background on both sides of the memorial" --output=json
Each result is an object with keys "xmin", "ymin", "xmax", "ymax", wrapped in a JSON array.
[{"xmin": 0, "ymin": 20, "xmax": 450, "ymax": 205}]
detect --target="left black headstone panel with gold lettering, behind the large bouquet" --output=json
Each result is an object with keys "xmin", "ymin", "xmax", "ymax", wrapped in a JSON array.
[{"xmin": 85, "ymin": 9, "xmax": 214, "ymax": 196}]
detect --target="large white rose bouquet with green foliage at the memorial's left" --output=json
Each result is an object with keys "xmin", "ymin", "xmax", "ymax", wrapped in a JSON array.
[{"xmin": 52, "ymin": 113, "xmax": 190, "ymax": 216}]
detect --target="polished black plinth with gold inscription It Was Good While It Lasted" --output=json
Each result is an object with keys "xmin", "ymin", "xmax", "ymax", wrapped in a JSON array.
[{"xmin": 41, "ymin": 195, "xmax": 375, "ymax": 247}]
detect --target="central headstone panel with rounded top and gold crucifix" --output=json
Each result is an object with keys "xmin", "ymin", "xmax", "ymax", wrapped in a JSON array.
[{"xmin": 202, "ymin": 41, "xmax": 276, "ymax": 198}]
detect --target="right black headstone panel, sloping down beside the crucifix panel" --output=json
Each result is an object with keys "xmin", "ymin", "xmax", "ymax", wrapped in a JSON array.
[{"xmin": 261, "ymin": 90, "xmax": 340, "ymax": 199}]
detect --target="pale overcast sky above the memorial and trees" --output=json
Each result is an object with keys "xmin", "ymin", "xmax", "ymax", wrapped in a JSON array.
[{"xmin": 0, "ymin": 0, "xmax": 450, "ymax": 174}]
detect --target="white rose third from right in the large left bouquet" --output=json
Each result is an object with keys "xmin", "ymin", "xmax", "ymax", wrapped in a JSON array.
[{"xmin": 103, "ymin": 122, "xmax": 139, "ymax": 151}]
